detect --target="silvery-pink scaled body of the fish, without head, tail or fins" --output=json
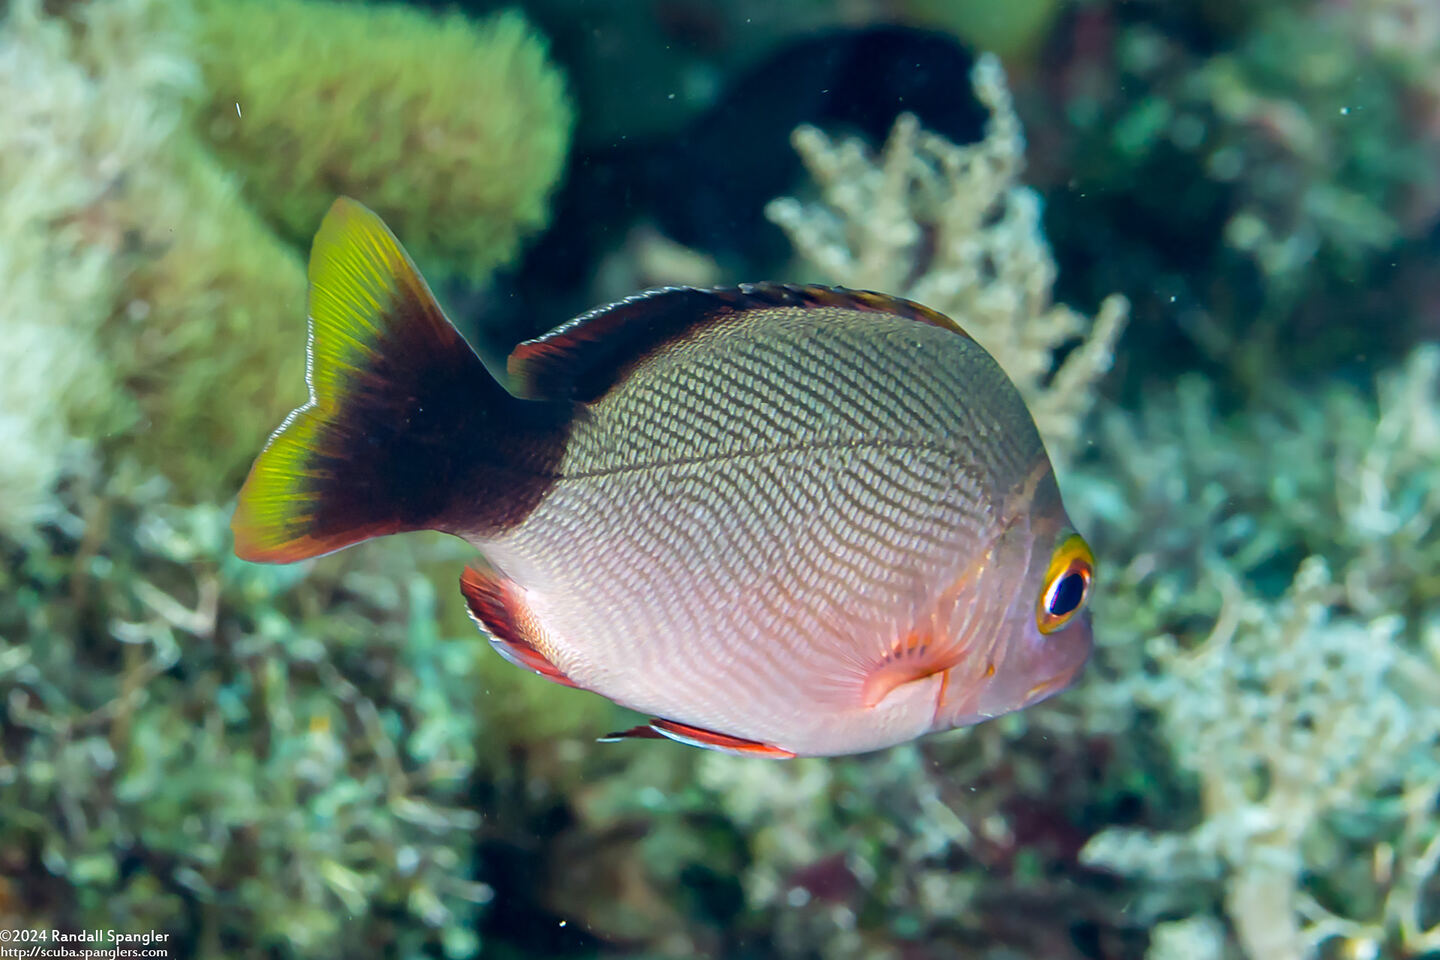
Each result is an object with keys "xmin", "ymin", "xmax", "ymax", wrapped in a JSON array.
[{"xmin": 477, "ymin": 308, "xmax": 1045, "ymax": 753}]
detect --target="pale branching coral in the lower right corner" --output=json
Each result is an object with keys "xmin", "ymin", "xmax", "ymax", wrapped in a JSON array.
[{"xmin": 1086, "ymin": 558, "xmax": 1440, "ymax": 960}]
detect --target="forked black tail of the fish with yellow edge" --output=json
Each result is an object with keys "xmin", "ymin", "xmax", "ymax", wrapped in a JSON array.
[{"xmin": 230, "ymin": 197, "xmax": 554, "ymax": 563}]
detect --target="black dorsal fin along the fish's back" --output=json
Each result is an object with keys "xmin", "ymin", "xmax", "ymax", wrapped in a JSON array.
[{"xmin": 508, "ymin": 284, "xmax": 968, "ymax": 403}]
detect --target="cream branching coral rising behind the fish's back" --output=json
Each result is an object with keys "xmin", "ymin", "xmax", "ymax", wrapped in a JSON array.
[{"xmin": 766, "ymin": 56, "xmax": 1128, "ymax": 459}]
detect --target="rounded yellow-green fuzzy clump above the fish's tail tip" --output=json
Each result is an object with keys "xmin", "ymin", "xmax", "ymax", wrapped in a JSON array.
[{"xmin": 197, "ymin": 0, "xmax": 573, "ymax": 279}]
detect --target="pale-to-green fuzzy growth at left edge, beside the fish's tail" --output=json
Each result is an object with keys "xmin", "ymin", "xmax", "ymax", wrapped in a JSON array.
[{"xmin": 0, "ymin": 0, "xmax": 305, "ymax": 509}]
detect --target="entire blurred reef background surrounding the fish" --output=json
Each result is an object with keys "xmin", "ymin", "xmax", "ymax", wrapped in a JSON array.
[{"xmin": 0, "ymin": 0, "xmax": 1440, "ymax": 960}]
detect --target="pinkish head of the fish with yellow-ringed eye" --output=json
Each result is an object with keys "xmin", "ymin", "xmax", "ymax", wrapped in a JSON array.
[{"xmin": 935, "ymin": 476, "xmax": 1094, "ymax": 730}]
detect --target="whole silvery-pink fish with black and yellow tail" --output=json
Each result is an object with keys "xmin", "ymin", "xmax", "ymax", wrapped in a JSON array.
[{"xmin": 232, "ymin": 199, "xmax": 1094, "ymax": 757}]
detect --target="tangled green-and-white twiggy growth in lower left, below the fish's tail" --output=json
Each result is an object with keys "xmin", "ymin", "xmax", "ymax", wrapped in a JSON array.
[{"xmin": 0, "ymin": 474, "xmax": 492, "ymax": 957}]
